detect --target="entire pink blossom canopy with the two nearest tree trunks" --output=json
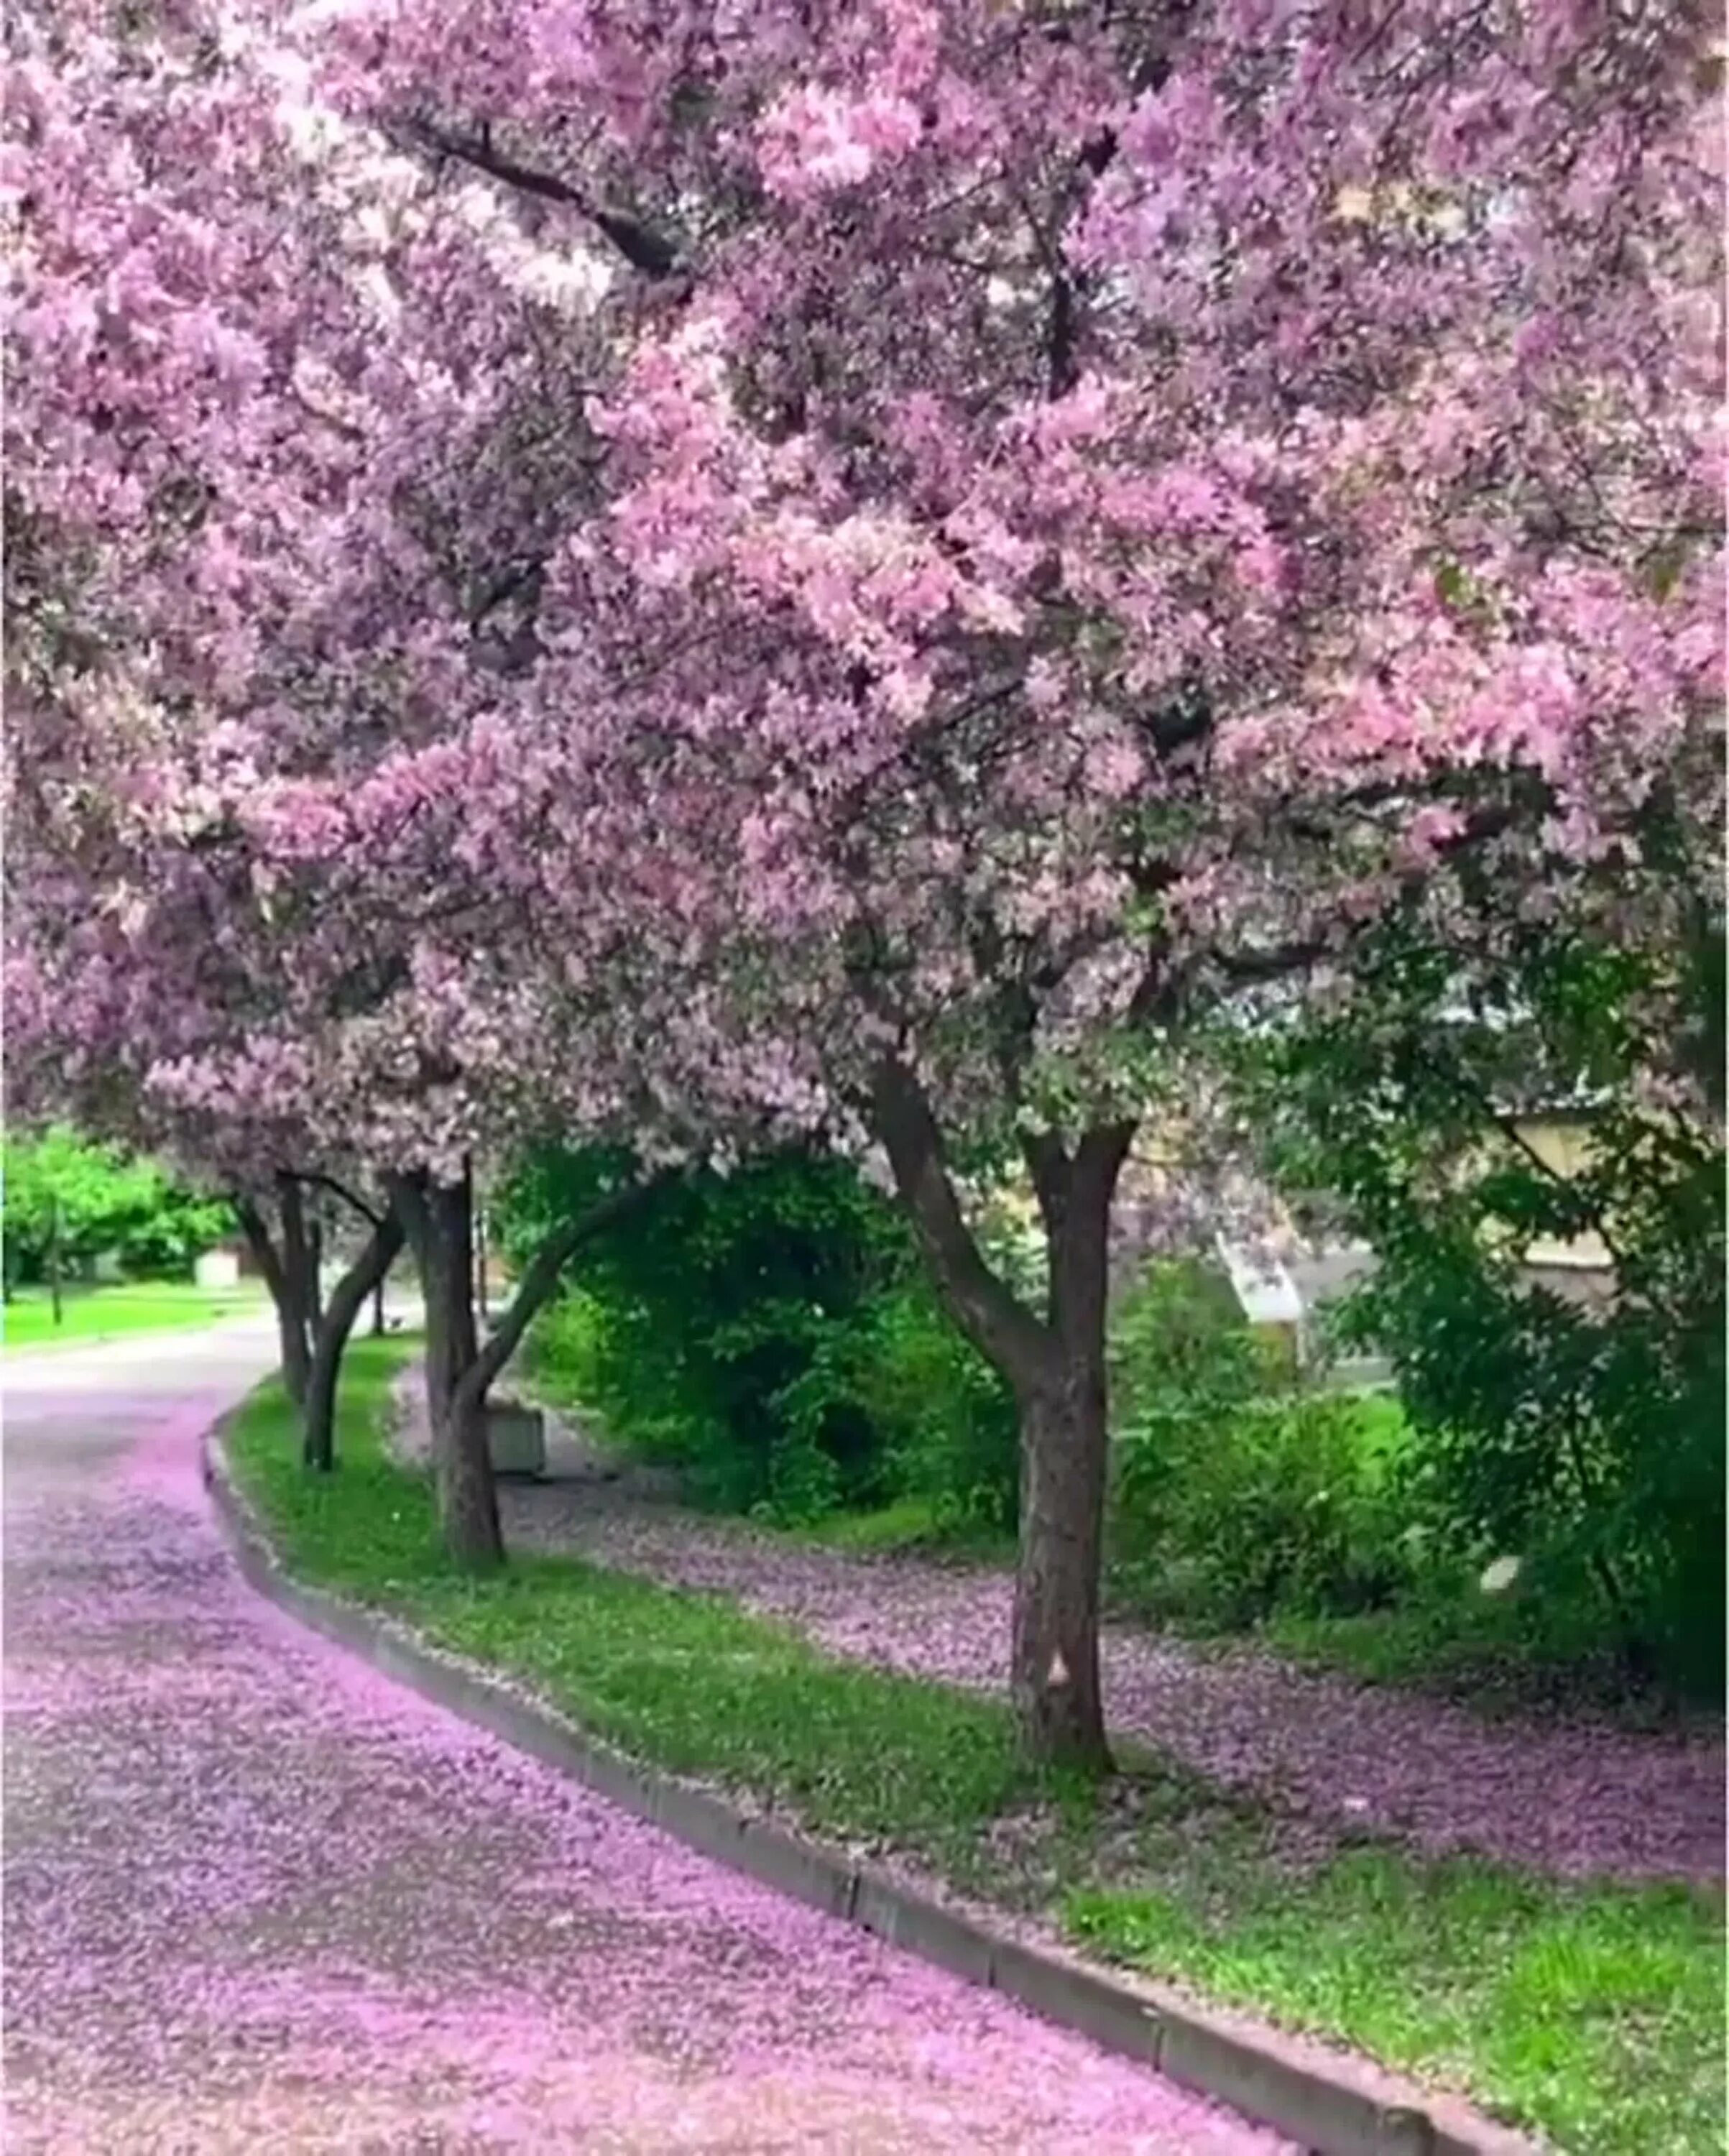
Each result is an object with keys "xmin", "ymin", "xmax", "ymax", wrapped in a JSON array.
[{"xmin": 6, "ymin": 0, "xmax": 1723, "ymax": 1759}]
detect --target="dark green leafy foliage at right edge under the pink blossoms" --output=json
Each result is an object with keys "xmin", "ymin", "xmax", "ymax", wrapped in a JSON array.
[{"xmin": 1259, "ymin": 934, "xmax": 1725, "ymax": 1690}]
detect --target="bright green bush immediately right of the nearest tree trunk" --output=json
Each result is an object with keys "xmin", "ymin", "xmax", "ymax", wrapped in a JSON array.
[{"xmin": 1110, "ymin": 1266, "xmax": 1421, "ymax": 1630}]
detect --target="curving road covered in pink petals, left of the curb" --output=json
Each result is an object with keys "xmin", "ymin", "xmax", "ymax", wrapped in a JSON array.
[{"xmin": 2, "ymin": 1328, "xmax": 1281, "ymax": 2156}]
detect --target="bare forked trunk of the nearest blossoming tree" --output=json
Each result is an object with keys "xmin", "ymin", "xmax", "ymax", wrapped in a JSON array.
[{"xmin": 873, "ymin": 1061, "xmax": 1134, "ymax": 1770}]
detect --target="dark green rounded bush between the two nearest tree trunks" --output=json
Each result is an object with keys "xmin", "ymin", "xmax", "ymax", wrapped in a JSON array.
[{"xmin": 500, "ymin": 1151, "xmax": 1015, "ymax": 1533}]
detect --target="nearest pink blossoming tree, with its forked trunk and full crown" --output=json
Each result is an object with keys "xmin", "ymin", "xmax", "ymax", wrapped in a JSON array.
[{"xmin": 319, "ymin": 0, "xmax": 1720, "ymax": 1757}]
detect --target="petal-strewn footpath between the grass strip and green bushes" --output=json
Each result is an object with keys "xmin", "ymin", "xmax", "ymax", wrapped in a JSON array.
[{"xmin": 397, "ymin": 1373, "xmax": 1725, "ymax": 1880}]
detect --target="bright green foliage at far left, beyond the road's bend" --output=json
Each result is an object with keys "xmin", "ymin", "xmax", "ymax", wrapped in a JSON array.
[{"xmin": 4, "ymin": 1123, "xmax": 233, "ymax": 1281}]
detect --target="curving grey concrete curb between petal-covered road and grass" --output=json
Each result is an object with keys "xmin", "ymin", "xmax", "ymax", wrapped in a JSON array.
[{"xmin": 203, "ymin": 1423, "xmax": 1537, "ymax": 2156}]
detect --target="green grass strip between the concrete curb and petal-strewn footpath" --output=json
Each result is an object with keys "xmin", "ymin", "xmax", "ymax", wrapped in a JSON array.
[{"xmin": 229, "ymin": 1339, "xmax": 1723, "ymax": 2156}]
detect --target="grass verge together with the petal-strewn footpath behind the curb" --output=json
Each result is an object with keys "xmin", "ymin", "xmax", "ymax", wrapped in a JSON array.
[{"xmin": 229, "ymin": 1341, "xmax": 1723, "ymax": 2156}]
